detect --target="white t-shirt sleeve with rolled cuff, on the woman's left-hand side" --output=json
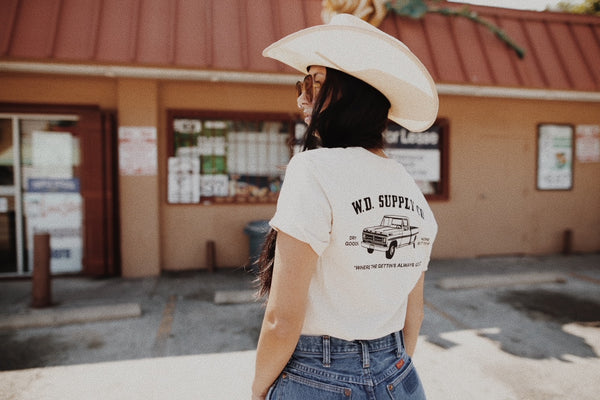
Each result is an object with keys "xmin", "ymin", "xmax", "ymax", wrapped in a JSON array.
[{"xmin": 270, "ymin": 153, "xmax": 332, "ymax": 256}]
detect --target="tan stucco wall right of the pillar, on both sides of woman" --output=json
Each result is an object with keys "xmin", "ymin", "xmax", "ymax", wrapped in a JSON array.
[{"xmin": 160, "ymin": 83, "xmax": 600, "ymax": 269}]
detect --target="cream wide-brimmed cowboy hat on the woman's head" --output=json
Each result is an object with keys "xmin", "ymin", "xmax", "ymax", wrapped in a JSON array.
[{"xmin": 263, "ymin": 14, "xmax": 439, "ymax": 132}]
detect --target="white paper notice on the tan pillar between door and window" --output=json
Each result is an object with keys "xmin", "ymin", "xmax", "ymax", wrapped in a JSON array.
[{"xmin": 119, "ymin": 126, "xmax": 157, "ymax": 176}]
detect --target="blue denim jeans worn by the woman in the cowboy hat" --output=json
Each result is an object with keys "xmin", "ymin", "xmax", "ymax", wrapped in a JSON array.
[{"xmin": 267, "ymin": 332, "xmax": 425, "ymax": 400}]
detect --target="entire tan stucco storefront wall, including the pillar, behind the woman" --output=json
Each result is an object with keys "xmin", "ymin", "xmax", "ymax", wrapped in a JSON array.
[{"xmin": 0, "ymin": 74, "xmax": 600, "ymax": 276}]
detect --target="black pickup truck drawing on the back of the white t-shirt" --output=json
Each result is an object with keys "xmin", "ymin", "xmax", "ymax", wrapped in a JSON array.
[{"xmin": 361, "ymin": 215, "xmax": 419, "ymax": 259}]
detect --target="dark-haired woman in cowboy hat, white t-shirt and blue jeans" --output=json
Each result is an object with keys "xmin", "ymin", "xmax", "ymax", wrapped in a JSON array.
[{"xmin": 252, "ymin": 15, "xmax": 438, "ymax": 400}]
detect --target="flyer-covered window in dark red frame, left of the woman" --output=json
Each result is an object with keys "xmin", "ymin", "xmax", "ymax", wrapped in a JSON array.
[{"xmin": 167, "ymin": 110, "xmax": 296, "ymax": 205}]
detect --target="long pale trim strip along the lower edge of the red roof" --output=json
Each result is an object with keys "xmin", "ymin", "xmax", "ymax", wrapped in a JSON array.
[{"xmin": 0, "ymin": 61, "xmax": 600, "ymax": 102}]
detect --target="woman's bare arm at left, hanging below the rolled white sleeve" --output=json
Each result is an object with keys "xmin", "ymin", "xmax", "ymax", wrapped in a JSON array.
[{"xmin": 252, "ymin": 232, "xmax": 318, "ymax": 399}]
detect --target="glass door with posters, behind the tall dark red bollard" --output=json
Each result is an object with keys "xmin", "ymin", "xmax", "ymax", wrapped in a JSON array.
[{"xmin": 21, "ymin": 120, "xmax": 83, "ymax": 273}]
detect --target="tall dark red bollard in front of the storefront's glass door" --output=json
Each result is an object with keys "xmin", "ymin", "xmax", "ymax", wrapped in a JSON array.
[{"xmin": 31, "ymin": 233, "xmax": 52, "ymax": 308}]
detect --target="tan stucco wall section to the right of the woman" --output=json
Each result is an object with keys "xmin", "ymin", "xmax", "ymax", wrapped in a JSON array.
[{"xmin": 433, "ymin": 97, "xmax": 600, "ymax": 258}]
